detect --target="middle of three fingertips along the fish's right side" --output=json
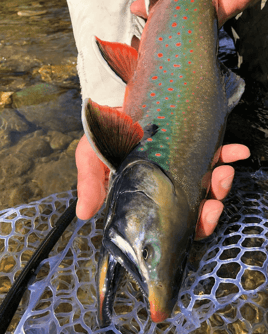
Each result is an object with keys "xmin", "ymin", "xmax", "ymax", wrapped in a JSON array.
[{"xmin": 210, "ymin": 165, "xmax": 235, "ymax": 200}]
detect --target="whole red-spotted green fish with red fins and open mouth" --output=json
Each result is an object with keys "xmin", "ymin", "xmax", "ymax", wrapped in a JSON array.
[{"xmin": 82, "ymin": 0, "xmax": 245, "ymax": 327}]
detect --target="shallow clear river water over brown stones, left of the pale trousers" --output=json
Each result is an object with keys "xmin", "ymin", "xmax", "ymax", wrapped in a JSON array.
[{"xmin": 0, "ymin": 0, "xmax": 82, "ymax": 209}]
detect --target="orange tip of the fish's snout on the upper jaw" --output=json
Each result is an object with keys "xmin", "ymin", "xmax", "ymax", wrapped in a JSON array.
[{"xmin": 148, "ymin": 282, "xmax": 176, "ymax": 322}]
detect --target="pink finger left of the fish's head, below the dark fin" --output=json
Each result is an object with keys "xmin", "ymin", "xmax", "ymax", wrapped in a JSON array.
[{"xmin": 75, "ymin": 135, "xmax": 106, "ymax": 220}]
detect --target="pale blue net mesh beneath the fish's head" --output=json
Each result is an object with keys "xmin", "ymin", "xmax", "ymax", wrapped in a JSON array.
[{"xmin": 0, "ymin": 169, "xmax": 268, "ymax": 334}]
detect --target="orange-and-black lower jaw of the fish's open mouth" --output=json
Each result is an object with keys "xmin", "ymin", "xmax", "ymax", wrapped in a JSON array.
[{"xmin": 97, "ymin": 247, "xmax": 123, "ymax": 327}]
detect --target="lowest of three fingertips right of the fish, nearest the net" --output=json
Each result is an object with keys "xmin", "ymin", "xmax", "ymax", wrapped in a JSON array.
[{"xmin": 195, "ymin": 199, "xmax": 224, "ymax": 240}]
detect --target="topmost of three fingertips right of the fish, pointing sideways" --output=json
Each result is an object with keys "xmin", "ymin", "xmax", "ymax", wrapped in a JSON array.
[{"xmin": 219, "ymin": 144, "xmax": 250, "ymax": 163}]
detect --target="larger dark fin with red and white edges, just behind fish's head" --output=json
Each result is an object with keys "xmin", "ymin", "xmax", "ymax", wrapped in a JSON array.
[{"xmin": 82, "ymin": 99, "xmax": 143, "ymax": 170}]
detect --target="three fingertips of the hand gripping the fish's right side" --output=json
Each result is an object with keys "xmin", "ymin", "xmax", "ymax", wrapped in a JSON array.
[{"xmin": 195, "ymin": 144, "xmax": 250, "ymax": 240}]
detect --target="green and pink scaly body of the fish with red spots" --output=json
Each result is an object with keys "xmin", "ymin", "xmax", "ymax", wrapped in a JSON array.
[{"xmin": 125, "ymin": 0, "xmax": 226, "ymax": 206}]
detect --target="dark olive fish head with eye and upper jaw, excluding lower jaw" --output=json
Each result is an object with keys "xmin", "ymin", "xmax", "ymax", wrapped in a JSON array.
[{"xmin": 103, "ymin": 160, "xmax": 194, "ymax": 322}]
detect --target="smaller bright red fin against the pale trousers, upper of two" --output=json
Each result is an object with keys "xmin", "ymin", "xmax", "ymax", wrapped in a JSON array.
[{"xmin": 96, "ymin": 37, "xmax": 138, "ymax": 83}]
